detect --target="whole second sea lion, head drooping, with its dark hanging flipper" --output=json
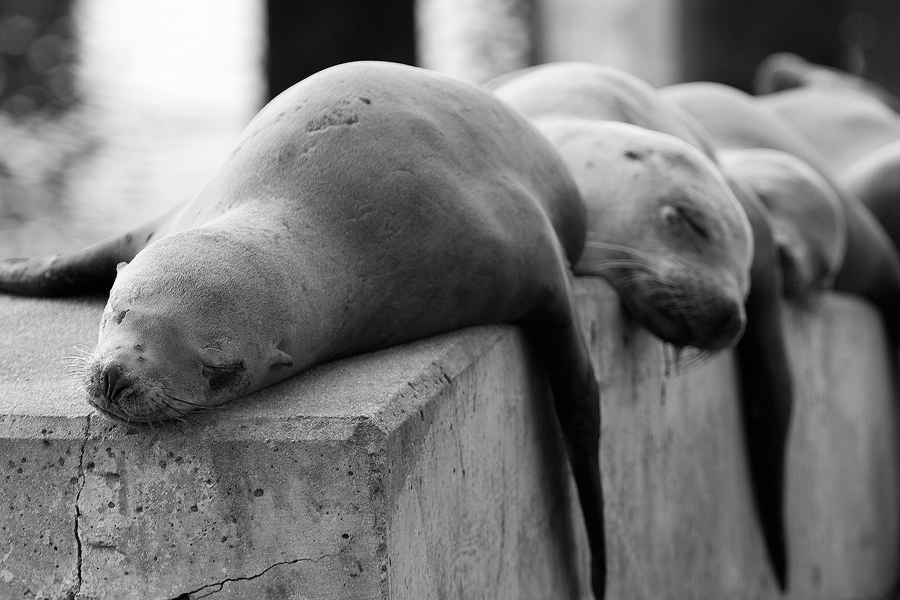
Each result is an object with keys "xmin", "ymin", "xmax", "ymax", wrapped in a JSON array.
[{"xmin": 488, "ymin": 63, "xmax": 793, "ymax": 589}]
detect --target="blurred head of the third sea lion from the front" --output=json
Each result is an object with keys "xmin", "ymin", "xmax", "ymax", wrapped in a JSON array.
[{"xmin": 721, "ymin": 149, "xmax": 847, "ymax": 298}]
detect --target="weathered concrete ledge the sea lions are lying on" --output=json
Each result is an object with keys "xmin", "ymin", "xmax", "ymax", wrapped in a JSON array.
[{"xmin": 0, "ymin": 280, "xmax": 900, "ymax": 600}]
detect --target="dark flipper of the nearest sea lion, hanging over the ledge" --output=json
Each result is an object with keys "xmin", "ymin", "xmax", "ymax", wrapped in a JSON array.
[{"xmin": 522, "ymin": 278, "xmax": 606, "ymax": 600}]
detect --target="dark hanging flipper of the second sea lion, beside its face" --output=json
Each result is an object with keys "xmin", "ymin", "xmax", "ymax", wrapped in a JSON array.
[{"xmin": 727, "ymin": 177, "xmax": 793, "ymax": 590}]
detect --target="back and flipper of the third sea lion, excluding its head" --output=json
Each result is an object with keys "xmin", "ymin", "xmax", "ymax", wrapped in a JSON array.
[{"xmin": 661, "ymin": 82, "xmax": 900, "ymax": 343}]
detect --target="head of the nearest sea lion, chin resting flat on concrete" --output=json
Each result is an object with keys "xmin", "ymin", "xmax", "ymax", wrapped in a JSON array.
[{"xmin": 84, "ymin": 228, "xmax": 293, "ymax": 423}]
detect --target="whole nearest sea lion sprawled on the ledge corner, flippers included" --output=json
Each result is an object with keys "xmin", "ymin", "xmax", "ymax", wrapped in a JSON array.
[{"xmin": 0, "ymin": 62, "xmax": 606, "ymax": 598}]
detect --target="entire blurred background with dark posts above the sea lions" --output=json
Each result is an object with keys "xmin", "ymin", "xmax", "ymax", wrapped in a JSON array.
[{"xmin": 0, "ymin": 0, "xmax": 900, "ymax": 258}]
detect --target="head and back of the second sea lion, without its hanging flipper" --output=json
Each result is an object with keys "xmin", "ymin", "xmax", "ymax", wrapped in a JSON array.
[{"xmin": 486, "ymin": 63, "xmax": 752, "ymax": 350}]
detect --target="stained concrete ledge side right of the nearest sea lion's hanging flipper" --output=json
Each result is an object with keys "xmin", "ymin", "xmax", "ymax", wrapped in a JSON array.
[{"xmin": 581, "ymin": 288, "xmax": 900, "ymax": 600}]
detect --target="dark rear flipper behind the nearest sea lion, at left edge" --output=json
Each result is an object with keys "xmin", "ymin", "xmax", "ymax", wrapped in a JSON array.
[{"xmin": 0, "ymin": 217, "xmax": 169, "ymax": 296}]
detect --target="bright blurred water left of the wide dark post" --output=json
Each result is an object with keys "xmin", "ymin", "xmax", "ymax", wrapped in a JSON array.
[{"xmin": 0, "ymin": 0, "xmax": 264, "ymax": 258}]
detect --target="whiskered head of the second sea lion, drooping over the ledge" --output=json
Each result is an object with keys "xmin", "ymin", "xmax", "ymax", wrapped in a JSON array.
[{"xmin": 538, "ymin": 119, "xmax": 753, "ymax": 350}]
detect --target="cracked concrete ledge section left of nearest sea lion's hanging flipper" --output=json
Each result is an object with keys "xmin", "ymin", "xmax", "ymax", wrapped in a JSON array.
[{"xmin": 0, "ymin": 297, "xmax": 584, "ymax": 599}]
